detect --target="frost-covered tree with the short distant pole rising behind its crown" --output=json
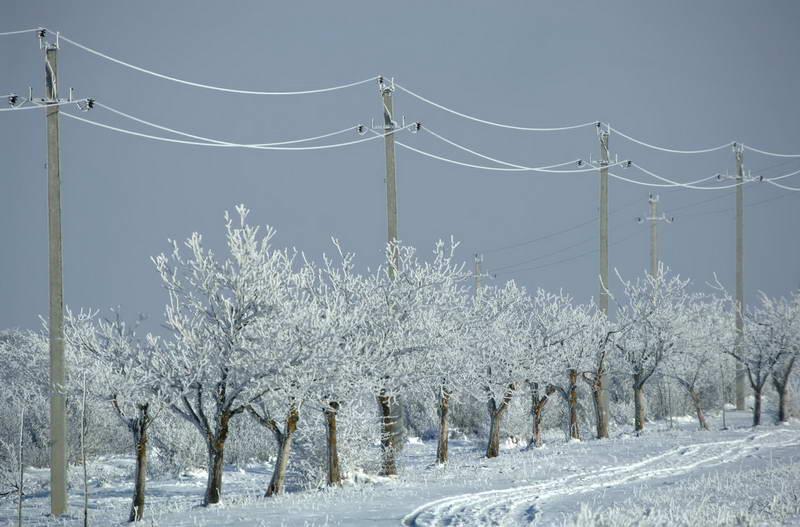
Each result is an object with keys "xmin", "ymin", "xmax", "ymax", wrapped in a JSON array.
[{"xmin": 614, "ymin": 263, "xmax": 696, "ymax": 432}]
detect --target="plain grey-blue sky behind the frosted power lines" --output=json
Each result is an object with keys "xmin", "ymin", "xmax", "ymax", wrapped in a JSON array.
[{"xmin": 0, "ymin": 0, "xmax": 800, "ymax": 328}]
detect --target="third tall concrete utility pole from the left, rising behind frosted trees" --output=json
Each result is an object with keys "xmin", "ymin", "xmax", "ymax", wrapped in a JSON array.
[{"xmin": 594, "ymin": 126, "xmax": 609, "ymax": 438}]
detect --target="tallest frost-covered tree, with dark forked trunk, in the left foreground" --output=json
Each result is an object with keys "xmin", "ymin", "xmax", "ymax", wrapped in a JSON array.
[{"xmin": 153, "ymin": 206, "xmax": 292, "ymax": 505}]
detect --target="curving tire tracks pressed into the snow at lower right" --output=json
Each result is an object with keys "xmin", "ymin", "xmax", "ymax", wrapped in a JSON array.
[{"xmin": 403, "ymin": 429, "xmax": 798, "ymax": 526}]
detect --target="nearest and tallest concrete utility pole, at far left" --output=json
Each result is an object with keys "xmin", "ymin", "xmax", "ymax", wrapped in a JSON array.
[{"xmin": 45, "ymin": 44, "xmax": 67, "ymax": 516}]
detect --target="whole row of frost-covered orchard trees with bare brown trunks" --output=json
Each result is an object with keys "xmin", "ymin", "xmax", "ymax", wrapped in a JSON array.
[{"xmin": 10, "ymin": 207, "xmax": 800, "ymax": 521}]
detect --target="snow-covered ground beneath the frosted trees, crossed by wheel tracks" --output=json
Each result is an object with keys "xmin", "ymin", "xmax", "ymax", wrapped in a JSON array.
[{"xmin": 0, "ymin": 413, "xmax": 800, "ymax": 527}]
